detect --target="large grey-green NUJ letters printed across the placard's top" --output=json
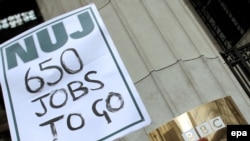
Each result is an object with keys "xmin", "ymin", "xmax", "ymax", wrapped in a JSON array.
[{"xmin": 5, "ymin": 11, "xmax": 94, "ymax": 70}]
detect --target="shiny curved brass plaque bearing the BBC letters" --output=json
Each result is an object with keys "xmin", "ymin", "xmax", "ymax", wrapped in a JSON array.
[{"xmin": 149, "ymin": 96, "xmax": 250, "ymax": 141}]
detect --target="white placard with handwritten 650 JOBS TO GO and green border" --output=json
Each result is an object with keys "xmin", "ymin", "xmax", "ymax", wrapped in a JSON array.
[{"xmin": 0, "ymin": 4, "xmax": 150, "ymax": 141}]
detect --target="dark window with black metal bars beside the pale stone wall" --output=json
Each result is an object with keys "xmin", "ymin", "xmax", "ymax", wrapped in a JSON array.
[{"xmin": 190, "ymin": 0, "xmax": 250, "ymax": 97}]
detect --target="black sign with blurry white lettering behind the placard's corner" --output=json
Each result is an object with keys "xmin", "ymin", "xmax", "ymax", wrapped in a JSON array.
[{"xmin": 0, "ymin": 0, "xmax": 43, "ymax": 44}]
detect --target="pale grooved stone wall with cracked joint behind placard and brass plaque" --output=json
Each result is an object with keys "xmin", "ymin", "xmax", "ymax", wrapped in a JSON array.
[{"xmin": 37, "ymin": 0, "xmax": 250, "ymax": 141}]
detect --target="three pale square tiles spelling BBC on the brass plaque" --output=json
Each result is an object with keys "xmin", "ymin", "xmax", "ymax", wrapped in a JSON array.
[{"xmin": 182, "ymin": 116, "xmax": 226, "ymax": 141}]
